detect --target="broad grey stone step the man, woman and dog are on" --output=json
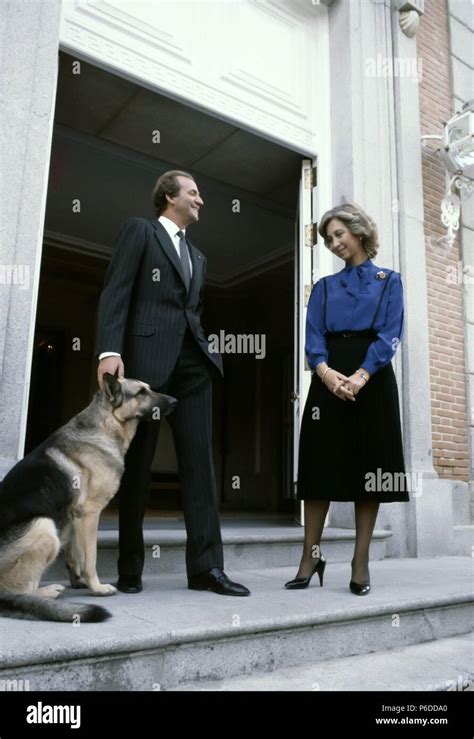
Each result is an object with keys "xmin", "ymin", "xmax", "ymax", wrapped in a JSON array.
[{"xmin": 0, "ymin": 557, "xmax": 474, "ymax": 690}]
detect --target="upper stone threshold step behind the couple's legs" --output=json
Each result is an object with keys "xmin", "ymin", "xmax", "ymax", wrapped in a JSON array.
[{"xmin": 48, "ymin": 522, "xmax": 391, "ymax": 579}]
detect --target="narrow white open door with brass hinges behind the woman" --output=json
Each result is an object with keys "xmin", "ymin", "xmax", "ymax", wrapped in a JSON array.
[{"xmin": 291, "ymin": 159, "xmax": 317, "ymax": 525}]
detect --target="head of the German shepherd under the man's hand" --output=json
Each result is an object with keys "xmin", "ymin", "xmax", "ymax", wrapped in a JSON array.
[{"xmin": 103, "ymin": 372, "xmax": 178, "ymax": 423}]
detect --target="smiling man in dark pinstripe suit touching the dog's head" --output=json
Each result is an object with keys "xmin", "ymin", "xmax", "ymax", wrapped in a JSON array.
[{"xmin": 96, "ymin": 170, "xmax": 250, "ymax": 595}]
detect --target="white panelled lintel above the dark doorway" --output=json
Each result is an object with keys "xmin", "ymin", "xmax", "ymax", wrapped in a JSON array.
[{"xmin": 60, "ymin": 0, "xmax": 328, "ymax": 155}]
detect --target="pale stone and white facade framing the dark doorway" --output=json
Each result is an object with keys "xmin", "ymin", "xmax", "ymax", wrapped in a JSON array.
[{"xmin": 0, "ymin": 0, "xmax": 474, "ymax": 556}]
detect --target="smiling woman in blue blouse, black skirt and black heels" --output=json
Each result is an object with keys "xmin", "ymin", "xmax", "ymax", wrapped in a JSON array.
[{"xmin": 285, "ymin": 203, "xmax": 409, "ymax": 595}]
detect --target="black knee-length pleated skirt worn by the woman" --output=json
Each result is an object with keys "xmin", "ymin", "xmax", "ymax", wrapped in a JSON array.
[{"xmin": 297, "ymin": 332, "xmax": 409, "ymax": 503}]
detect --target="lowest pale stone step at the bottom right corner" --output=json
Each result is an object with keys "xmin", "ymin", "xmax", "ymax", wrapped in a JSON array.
[{"xmin": 171, "ymin": 634, "xmax": 474, "ymax": 692}]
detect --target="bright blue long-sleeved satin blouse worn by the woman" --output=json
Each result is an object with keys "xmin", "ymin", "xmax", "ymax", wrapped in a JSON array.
[{"xmin": 305, "ymin": 259, "xmax": 403, "ymax": 375}]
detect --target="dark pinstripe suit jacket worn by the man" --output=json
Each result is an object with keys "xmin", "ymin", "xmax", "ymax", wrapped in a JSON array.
[{"xmin": 96, "ymin": 218, "xmax": 223, "ymax": 388}]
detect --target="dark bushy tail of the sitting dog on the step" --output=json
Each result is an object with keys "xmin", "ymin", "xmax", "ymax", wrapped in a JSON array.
[{"xmin": 0, "ymin": 593, "xmax": 112, "ymax": 623}]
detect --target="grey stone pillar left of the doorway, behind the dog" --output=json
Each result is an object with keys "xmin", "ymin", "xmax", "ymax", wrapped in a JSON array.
[{"xmin": 0, "ymin": 0, "xmax": 61, "ymax": 479}]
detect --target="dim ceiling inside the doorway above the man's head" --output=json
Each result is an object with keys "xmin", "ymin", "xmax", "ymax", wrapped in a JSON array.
[{"xmin": 46, "ymin": 53, "xmax": 302, "ymax": 284}]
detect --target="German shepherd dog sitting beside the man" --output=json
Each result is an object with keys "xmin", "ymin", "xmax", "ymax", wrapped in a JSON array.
[{"xmin": 0, "ymin": 374, "xmax": 177, "ymax": 622}]
